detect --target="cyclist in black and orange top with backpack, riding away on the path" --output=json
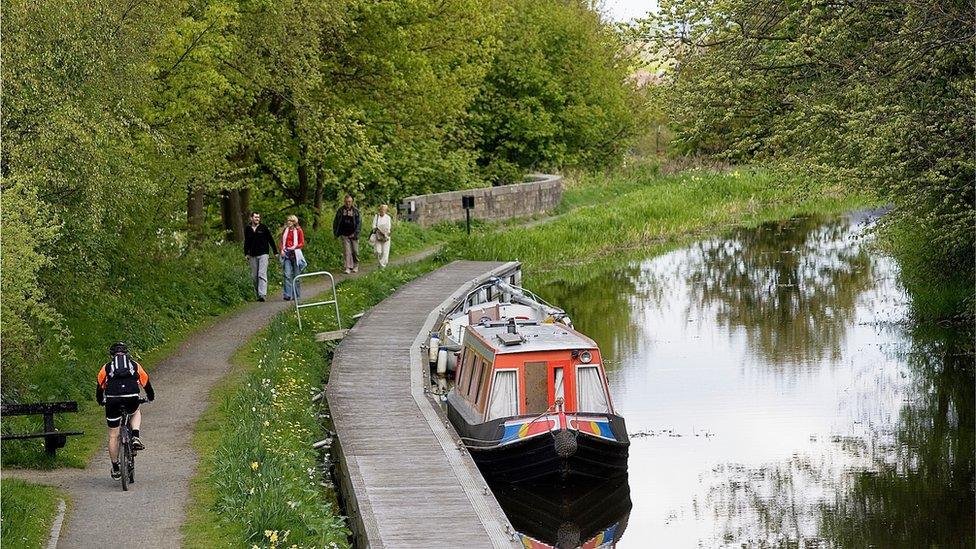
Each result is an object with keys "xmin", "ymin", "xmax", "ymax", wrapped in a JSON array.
[{"xmin": 95, "ymin": 341, "xmax": 156, "ymax": 480}]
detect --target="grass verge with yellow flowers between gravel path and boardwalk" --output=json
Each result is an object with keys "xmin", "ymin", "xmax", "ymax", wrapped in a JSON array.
[{"xmin": 184, "ymin": 260, "xmax": 438, "ymax": 547}]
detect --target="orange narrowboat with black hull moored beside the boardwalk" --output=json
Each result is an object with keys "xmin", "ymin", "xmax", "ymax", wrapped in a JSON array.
[{"xmin": 447, "ymin": 318, "xmax": 630, "ymax": 484}]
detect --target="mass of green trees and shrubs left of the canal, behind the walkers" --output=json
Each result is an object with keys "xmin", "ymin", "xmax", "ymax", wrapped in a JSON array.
[{"xmin": 0, "ymin": 0, "xmax": 629, "ymax": 399}]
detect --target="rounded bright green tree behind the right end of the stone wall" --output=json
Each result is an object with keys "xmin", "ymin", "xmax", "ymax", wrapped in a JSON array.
[{"xmin": 471, "ymin": 0, "xmax": 639, "ymax": 183}]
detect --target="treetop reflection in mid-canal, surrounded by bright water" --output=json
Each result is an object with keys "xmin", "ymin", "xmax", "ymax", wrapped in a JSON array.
[{"xmin": 681, "ymin": 217, "xmax": 873, "ymax": 364}]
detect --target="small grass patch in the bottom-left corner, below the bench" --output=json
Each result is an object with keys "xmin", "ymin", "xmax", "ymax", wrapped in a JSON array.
[{"xmin": 0, "ymin": 479, "xmax": 62, "ymax": 549}]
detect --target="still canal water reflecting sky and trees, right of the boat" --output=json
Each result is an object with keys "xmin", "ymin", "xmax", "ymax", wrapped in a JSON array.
[{"xmin": 516, "ymin": 212, "xmax": 974, "ymax": 548}]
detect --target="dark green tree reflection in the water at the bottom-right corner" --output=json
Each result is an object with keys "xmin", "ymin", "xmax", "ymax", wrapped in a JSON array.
[{"xmin": 822, "ymin": 328, "xmax": 976, "ymax": 547}]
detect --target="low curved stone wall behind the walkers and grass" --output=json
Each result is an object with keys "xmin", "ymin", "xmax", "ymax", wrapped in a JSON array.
[{"xmin": 398, "ymin": 174, "xmax": 563, "ymax": 227}]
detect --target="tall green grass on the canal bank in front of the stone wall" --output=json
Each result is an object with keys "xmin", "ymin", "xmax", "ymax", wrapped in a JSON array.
[{"xmin": 445, "ymin": 166, "xmax": 867, "ymax": 281}]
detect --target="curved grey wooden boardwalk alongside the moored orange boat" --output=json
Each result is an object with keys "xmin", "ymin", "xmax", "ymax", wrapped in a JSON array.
[{"xmin": 327, "ymin": 261, "xmax": 518, "ymax": 549}]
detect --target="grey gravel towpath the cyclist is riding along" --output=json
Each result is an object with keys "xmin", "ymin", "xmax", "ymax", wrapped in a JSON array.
[{"xmin": 3, "ymin": 248, "xmax": 437, "ymax": 549}]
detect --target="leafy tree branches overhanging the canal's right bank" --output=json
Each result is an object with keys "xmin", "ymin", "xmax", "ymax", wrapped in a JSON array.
[{"xmin": 643, "ymin": 0, "xmax": 976, "ymax": 318}]
